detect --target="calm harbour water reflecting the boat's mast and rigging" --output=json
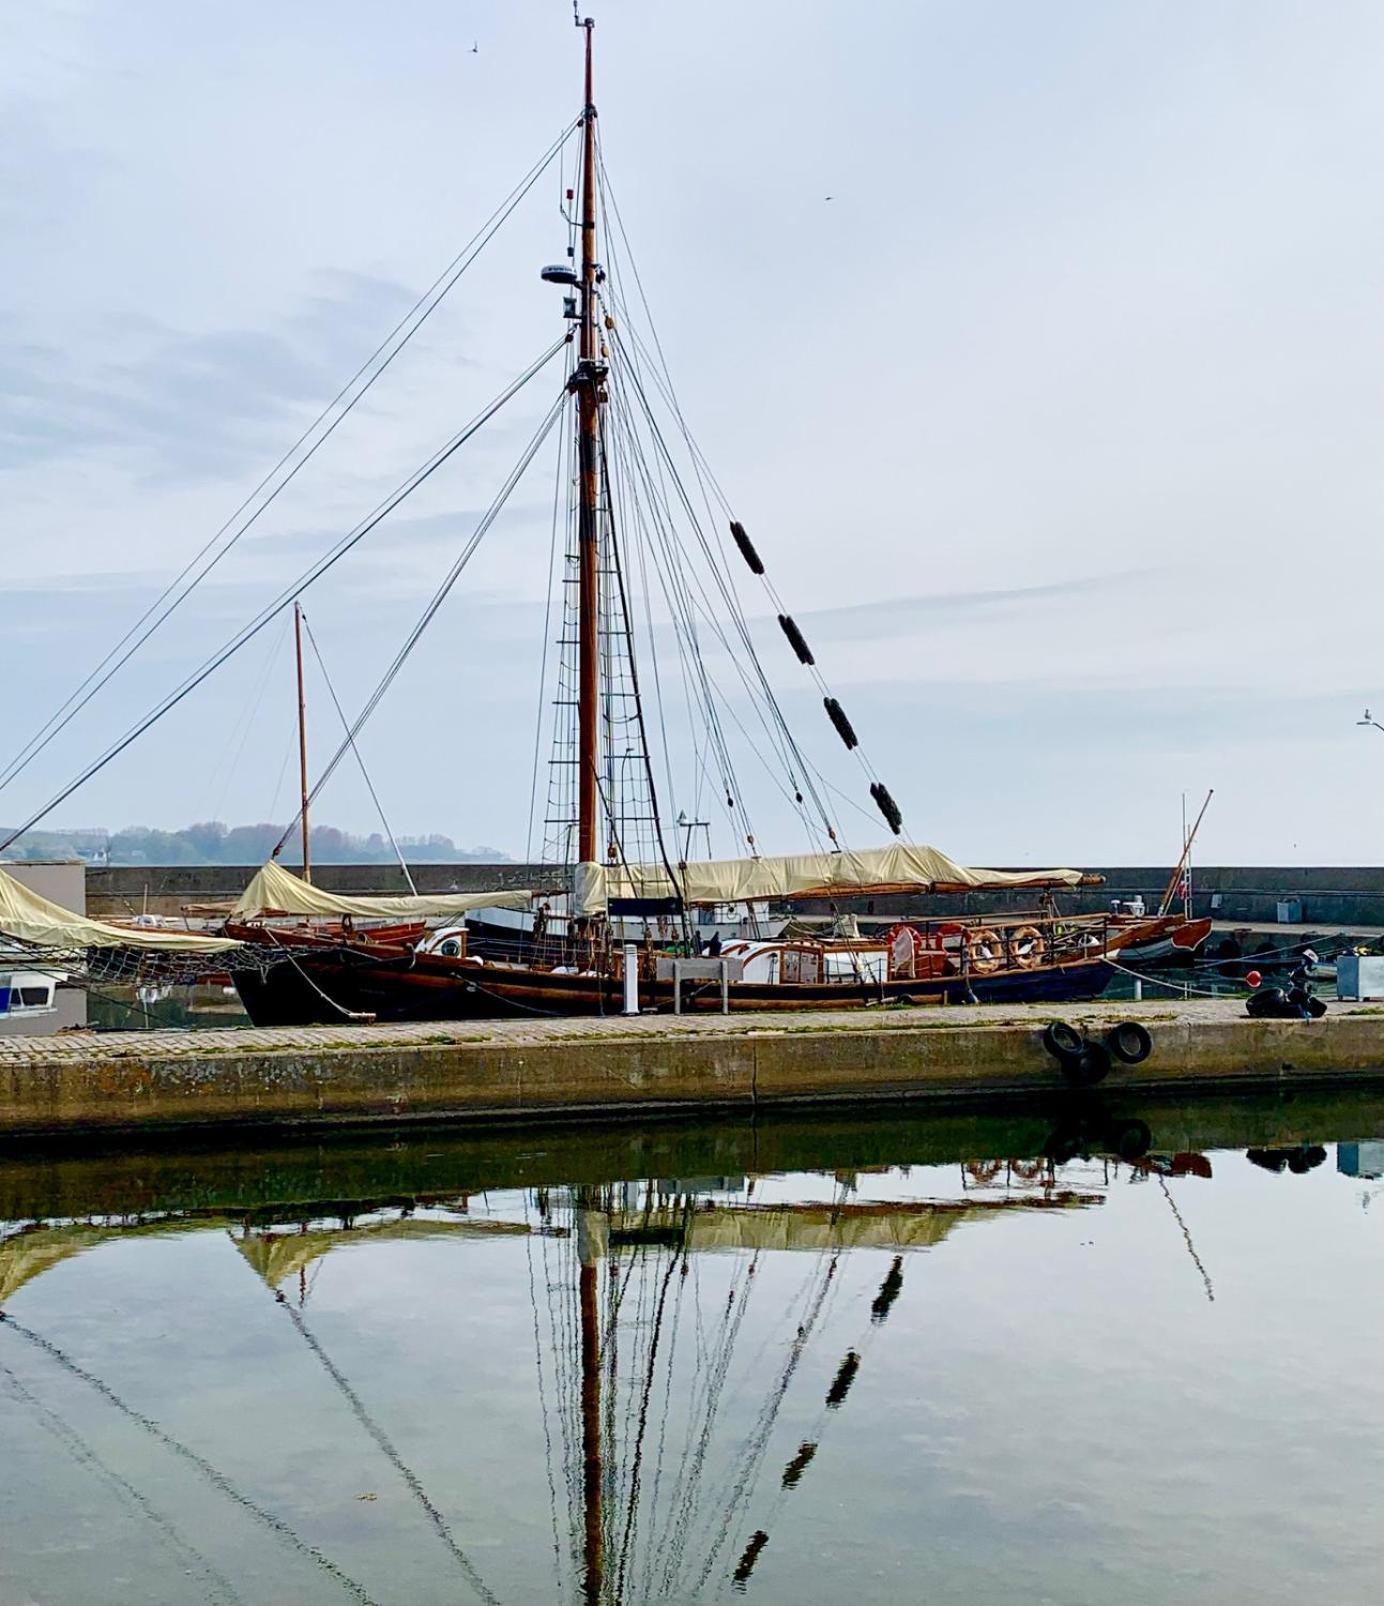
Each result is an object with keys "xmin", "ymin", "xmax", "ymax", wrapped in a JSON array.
[{"xmin": 0, "ymin": 1090, "xmax": 1384, "ymax": 1606}]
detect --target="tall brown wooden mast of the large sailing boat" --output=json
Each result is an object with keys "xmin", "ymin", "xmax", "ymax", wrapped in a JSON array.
[{"xmin": 572, "ymin": 18, "xmax": 605, "ymax": 862}]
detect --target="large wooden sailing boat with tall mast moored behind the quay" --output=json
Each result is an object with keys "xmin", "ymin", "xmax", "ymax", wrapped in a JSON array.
[{"xmin": 225, "ymin": 19, "xmax": 1180, "ymax": 1025}]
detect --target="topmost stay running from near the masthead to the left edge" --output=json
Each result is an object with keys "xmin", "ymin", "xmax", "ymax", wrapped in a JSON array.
[{"xmin": 0, "ymin": 119, "xmax": 580, "ymax": 792}]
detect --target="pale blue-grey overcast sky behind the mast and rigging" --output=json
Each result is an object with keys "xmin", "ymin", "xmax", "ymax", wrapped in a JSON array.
[{"xmin": 0, "ymin": 0, "xmax": 1384, "ymax": 864}]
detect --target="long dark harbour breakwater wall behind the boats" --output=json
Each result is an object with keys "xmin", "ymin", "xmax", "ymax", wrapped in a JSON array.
[{"xmin": 87, "ymin": 864, "xmax": 1384, "ymax": 927}]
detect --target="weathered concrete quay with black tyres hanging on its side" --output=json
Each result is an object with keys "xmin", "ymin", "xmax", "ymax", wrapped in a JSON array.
[{"xmin": 0, "ymin": 1004, "xmax": 1384, "ymax": 1137}]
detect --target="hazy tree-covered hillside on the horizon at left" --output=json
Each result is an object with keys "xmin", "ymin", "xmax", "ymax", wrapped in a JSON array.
[{"xmin": 5, "ymin": 819, "xmax": 509, "ymax": 864}]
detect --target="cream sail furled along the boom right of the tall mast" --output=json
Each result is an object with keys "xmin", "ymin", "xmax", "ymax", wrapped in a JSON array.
[{"xmin": 575, "ymin": 843, "xmax": 1082, "ymax": 914}]
